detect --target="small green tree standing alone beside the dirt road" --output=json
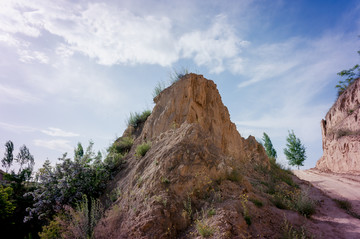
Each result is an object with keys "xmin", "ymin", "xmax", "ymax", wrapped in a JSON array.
[{"xmin": 284, "ymin": 130, "xmax": 306, "ymax": 169}]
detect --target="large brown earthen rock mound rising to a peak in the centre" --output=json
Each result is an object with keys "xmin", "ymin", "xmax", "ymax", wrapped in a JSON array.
[{"xmin": 94, "ymin": 74, "xmax": 283, "ymax": 239}]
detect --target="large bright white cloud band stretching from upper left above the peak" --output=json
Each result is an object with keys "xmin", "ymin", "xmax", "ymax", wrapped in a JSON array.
[{"xmin": 0, "ymin": 0, "xmax": 247, "ymax": 73}]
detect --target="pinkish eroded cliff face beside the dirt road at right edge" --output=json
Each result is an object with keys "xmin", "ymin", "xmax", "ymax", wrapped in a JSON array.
[{"xmin": 316, "ymin": 79, "xmax": 360, "ymax": 174}]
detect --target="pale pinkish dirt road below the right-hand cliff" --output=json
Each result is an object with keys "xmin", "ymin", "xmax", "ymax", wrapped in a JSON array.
[{"xmin": 294, "ymin": 169, "xmax": 360, "ymax": 239}]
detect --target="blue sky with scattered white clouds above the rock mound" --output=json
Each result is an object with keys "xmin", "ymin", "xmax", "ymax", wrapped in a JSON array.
[{"xmin": 0, "ymin": 0, "xmax": 360, "ymax": 172}]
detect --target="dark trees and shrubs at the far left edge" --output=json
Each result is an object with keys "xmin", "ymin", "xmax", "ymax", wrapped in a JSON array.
[{"xmin": 0, "ymin": 140, "xmax": 40, "ymax": 238}]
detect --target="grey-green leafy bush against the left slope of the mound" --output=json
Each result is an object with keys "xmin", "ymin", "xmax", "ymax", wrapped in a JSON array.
[{"xmin": 26, "ymin": 142, "xmax": 111, "ymax": 220}]
